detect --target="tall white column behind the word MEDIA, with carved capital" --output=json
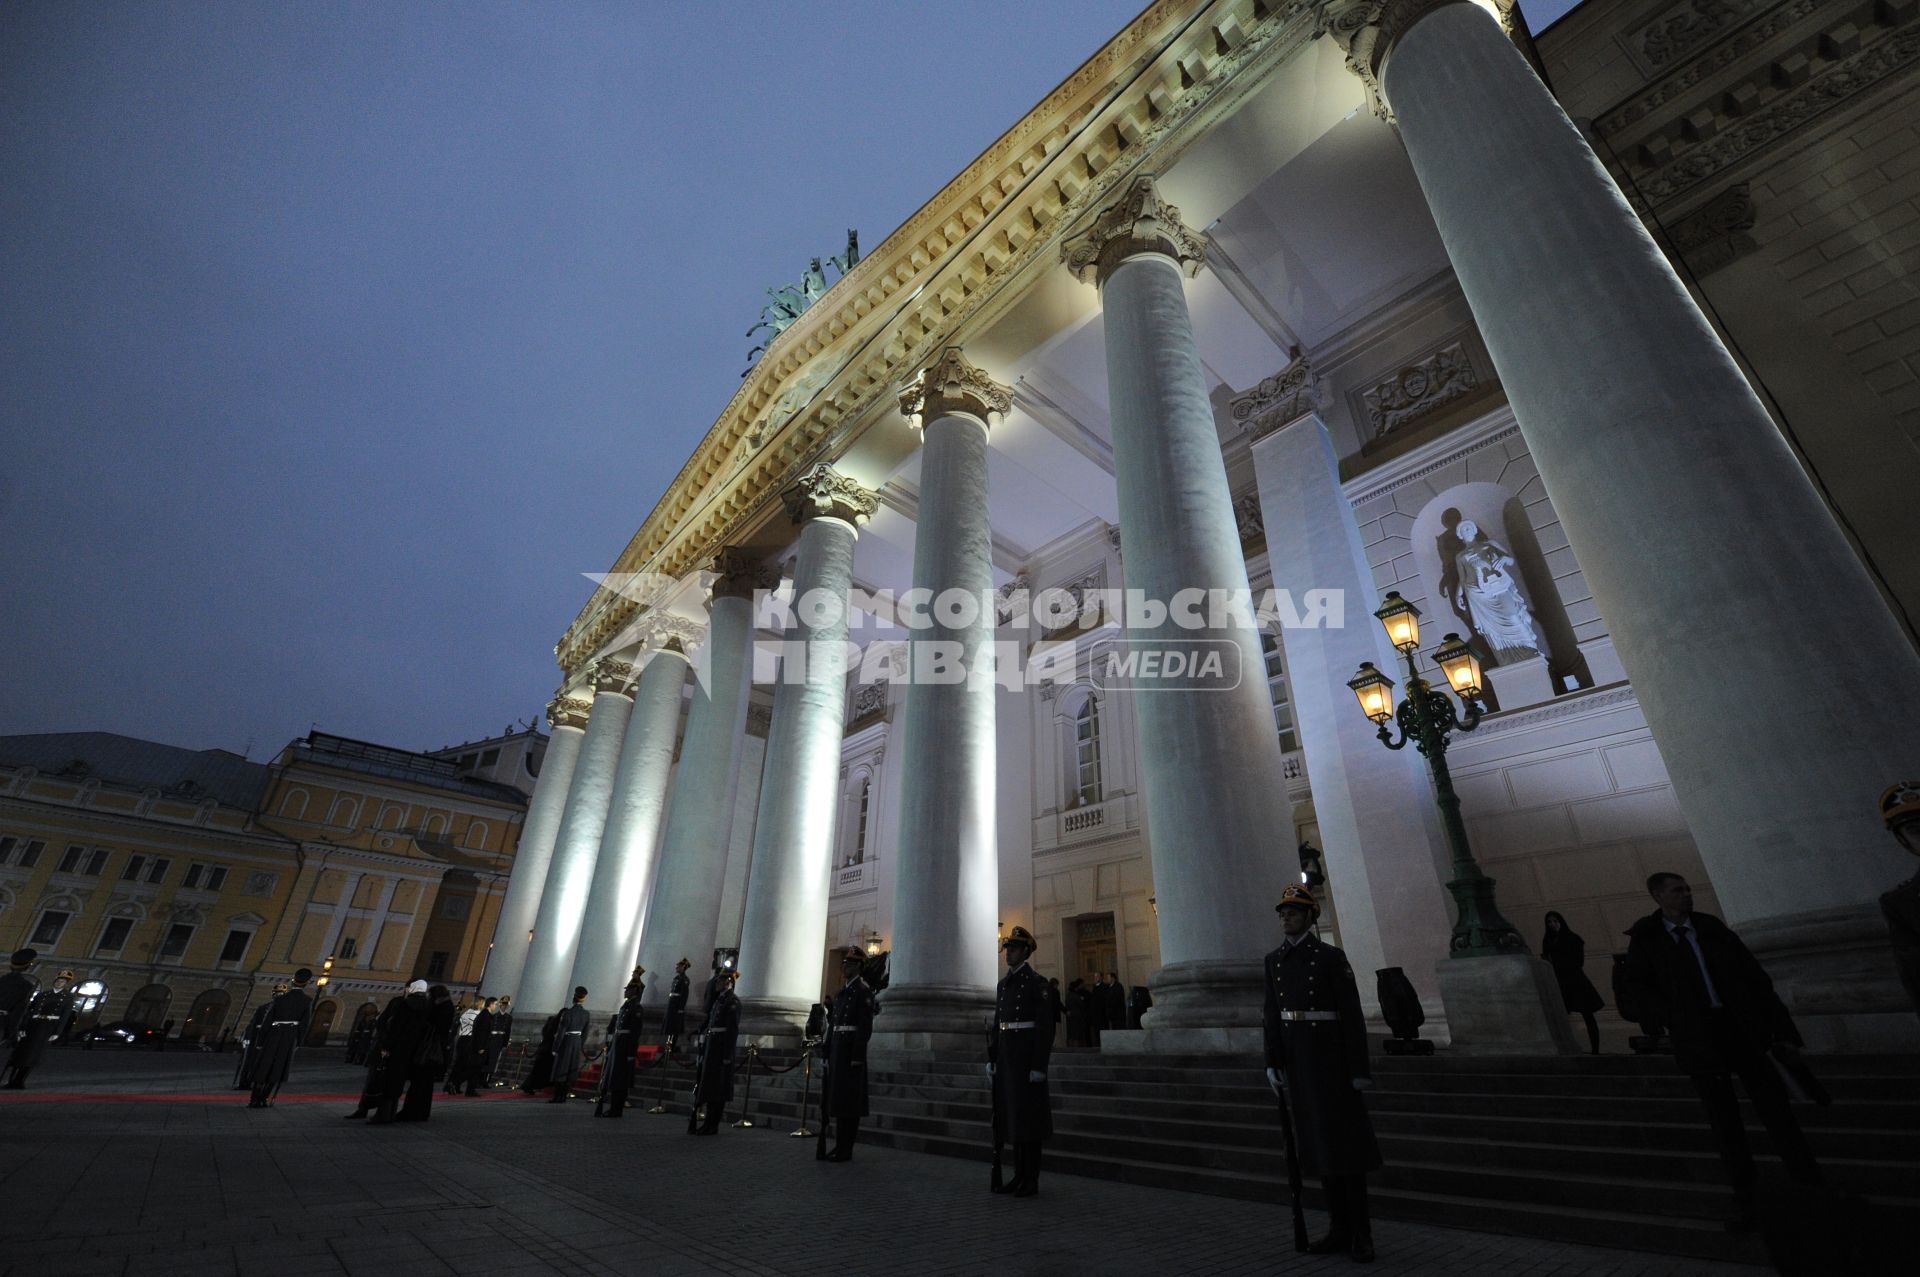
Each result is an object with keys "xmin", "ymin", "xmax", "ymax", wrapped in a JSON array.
[{"xmin": 1064, "ymin": 177, "xmax": 1298, "ymax": 1050}]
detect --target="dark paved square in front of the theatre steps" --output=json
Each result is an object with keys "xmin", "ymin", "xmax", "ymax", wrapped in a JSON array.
[{"xmin": 0, "ymin": 1050, "xmax": 1761, "ymax": 1277}]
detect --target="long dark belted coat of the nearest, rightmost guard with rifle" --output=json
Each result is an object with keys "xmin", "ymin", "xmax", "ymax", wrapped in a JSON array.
[{"xmin": 1265, "ymin": 931, "xmax": 1380, "ymax": 1175}]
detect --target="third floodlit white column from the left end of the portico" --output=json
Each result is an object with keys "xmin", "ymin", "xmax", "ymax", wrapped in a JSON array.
[{"xmin": 566, "ymin": 616, "xmax": 699, "ymax": 1014}]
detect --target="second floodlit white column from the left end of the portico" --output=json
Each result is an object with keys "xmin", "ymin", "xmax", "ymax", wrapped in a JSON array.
[{"xmin": 513, "ymin": 659, "xmax": 634, "ymax": 1014}]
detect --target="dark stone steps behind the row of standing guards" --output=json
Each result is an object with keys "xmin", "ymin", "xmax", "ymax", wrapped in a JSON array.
[{"xmin": 618, "ymin": 1052, "xmax": 1920, "ymax": 1262}]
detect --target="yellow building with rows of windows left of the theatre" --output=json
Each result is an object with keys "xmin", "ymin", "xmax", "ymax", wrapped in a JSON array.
[{"xmin": 0, "ymin": 732, "xmax": 543, "ymax": 1041}]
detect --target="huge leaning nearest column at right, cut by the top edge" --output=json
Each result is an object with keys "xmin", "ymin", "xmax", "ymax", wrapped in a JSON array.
[{"xmin": 1348, "ymin": 0, "xmax": 1920, "ymax": 1050}]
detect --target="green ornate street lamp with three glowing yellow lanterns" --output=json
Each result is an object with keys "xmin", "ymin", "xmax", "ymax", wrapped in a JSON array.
[{"xmin": 1346, "ymin": 591, "xmax": 1526, "ymax": 958}]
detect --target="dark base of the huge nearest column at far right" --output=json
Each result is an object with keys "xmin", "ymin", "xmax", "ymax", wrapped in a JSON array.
[{"xmin": 1734, "ymin": 904, "xmax": 1920, "ymax": 1052}]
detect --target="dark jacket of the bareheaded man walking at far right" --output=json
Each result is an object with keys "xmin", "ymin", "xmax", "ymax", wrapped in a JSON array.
[{"xmin": 1620, "ymin": 912, "xmax": 1801, "ymax": 1073}]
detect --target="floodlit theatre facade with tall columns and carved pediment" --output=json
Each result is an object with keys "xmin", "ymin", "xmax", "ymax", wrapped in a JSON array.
[{"xmin": 486, "ymin": 0, "xmax": 1920, "ymax": 1050}]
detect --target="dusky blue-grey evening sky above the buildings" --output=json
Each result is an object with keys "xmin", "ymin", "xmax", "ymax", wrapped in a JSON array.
[{"xmin": 0, "ymin": 0, "xmax": 1574, "ymax": 759}]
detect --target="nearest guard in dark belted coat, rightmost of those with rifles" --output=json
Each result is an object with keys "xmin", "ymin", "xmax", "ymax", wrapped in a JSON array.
[{"xmin": 1265, "ymin": 885, "xmax": 1380, "ymax": 1264}]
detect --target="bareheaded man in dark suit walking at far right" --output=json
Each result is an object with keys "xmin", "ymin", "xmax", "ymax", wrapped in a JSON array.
[{"xmin": 1620, "ymin": 874, "xmax": 1822, "ymax": 1231}]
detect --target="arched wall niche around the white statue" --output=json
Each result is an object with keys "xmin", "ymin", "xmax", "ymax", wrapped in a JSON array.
[{"xmin": 1409, "ymin": 484, "xmax": 1592, "ymax": 709}]
